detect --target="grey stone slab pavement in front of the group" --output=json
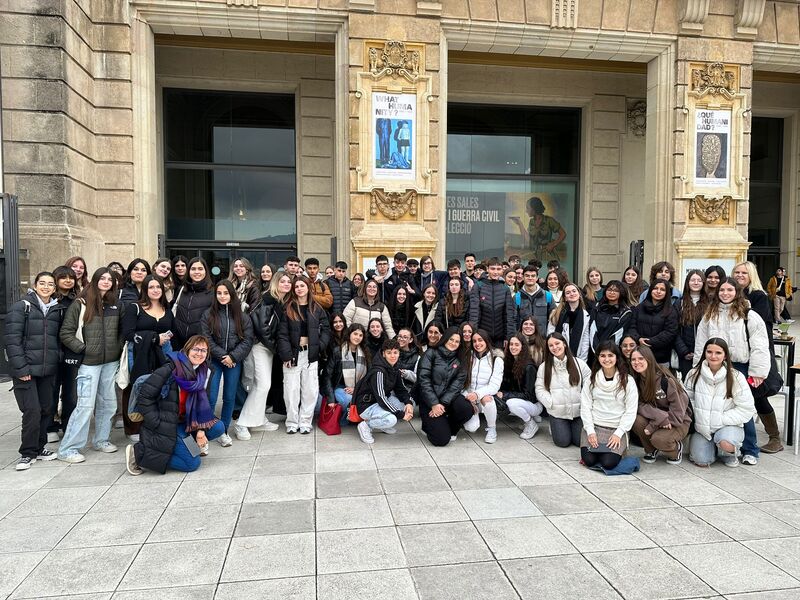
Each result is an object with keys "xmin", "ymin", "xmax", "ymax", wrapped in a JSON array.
[{"xmin": 0, "ymin": 384, "xmax": 800, "ymax": 600}]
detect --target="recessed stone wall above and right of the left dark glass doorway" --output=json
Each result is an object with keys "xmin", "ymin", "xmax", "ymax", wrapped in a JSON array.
[{"xmin": 155, "ymin": 46, "xmax": 334, "ymax": 266}]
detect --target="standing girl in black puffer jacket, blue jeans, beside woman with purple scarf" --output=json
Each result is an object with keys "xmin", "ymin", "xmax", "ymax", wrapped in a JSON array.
[{"xmin": 202, "ymin": 280, "xmax": 253, "ymax": 447}]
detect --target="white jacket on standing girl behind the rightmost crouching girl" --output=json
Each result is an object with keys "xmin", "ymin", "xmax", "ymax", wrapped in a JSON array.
[{"xmin": 694, "ymin": 303, "xmax": 770, "ymax": 377}]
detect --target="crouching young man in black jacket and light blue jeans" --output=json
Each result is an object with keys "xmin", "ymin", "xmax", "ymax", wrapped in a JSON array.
[{"xmin": 353, "ymin": 340, "xmax": 414, "ymax": 444}]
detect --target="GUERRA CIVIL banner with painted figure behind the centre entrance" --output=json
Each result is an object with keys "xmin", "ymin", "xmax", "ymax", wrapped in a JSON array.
[{"xmin": 446, "ymin": 182, "xmax": 576, "ymax": 273}]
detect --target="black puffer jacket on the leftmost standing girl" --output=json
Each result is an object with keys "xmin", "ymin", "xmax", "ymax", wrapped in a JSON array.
[{"xmin": 5, "ymin": 292, "xmax": 66, "ymax": 379}]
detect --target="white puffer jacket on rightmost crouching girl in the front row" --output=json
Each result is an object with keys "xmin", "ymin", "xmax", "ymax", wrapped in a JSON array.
[{"xmin": 686, "ymin": 361, "xmax": 756, "ymax": 440}]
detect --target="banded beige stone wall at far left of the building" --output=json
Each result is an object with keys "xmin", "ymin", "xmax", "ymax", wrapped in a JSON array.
[{"xmin": 0, "ymin": 0, "xmax": 134, "ymax": 272}]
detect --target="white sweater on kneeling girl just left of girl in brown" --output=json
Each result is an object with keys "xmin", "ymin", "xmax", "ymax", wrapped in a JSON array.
[{"xmin": 581, "ymin": 369, "xmax": 639, "ymax": 438}]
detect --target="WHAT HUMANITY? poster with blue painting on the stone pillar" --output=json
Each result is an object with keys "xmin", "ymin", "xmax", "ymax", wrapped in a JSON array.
[{"xmin": 372, "ymin": 92, "xmax": 417, "ymax": 181}]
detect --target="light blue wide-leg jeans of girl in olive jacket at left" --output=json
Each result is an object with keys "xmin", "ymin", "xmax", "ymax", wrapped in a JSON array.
[{"xmin": 58, "ymin": 361, "xmax": 119, "ymax": 457}]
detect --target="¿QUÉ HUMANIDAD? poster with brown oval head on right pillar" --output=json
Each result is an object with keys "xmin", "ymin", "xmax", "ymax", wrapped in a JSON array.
[{"xmin": 694, "ymin": 109, "xmax": 731, "ymax": 188}]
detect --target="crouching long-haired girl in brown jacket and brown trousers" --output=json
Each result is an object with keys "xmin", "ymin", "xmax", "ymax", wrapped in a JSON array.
[{"xmin": 631, "ymin": 346, "xmax": 692, "ymax": 465}]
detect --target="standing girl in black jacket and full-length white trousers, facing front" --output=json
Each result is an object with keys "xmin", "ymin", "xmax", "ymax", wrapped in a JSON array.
[{"xmin": 278, "ymin": 276, "xmax": 330, "ymax": 434}]
